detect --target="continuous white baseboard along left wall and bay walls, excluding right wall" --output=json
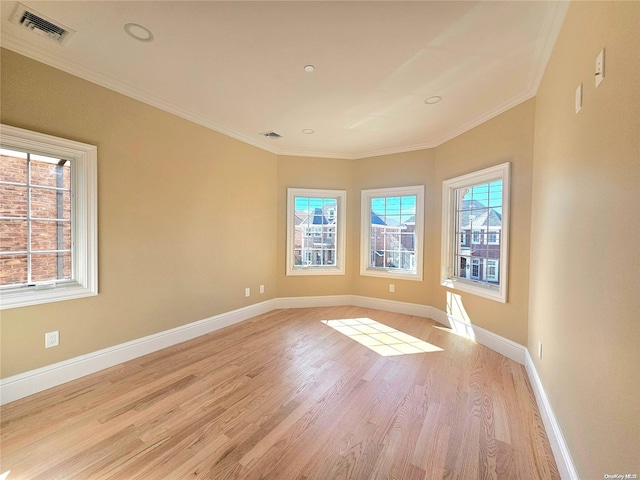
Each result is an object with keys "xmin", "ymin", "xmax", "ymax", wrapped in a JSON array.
[{"xmin": 0, "ymin": 295, "xmax": 526, "ymax": 405}]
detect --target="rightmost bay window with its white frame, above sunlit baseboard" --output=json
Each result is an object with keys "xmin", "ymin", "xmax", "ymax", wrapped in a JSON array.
[{"xmin": 441, "ymin": 163, "xmax": 510, "ymax": 303}]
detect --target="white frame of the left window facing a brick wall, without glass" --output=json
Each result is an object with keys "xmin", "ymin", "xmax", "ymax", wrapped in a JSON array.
[{"xmin": 0, "ymin": 125, "xmax": 98, "ymax": 310}]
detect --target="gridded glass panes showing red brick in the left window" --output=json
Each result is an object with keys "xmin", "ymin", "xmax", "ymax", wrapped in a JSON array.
[{"xmin": 0, "ymin": 149, "xmax": 72, "ymax": 287}]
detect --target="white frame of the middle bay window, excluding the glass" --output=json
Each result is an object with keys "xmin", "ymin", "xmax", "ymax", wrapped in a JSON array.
[{"xmin": 360, "ymin": 185, "xmax": 424, "ymax": 281}]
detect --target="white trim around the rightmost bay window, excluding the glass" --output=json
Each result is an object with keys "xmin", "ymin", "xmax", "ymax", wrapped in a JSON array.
[{"xmin": 440, "ymin": 162, "xmax": 511, "ymax": 303}]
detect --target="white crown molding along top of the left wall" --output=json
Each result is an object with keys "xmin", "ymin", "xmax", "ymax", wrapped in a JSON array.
[{"xmin": 0, "ymin": 31, "xmax": 278, "ymax": 158}]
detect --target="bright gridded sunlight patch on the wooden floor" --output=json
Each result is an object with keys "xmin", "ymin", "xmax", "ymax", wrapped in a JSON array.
[{"xmin": 322, "ymin": 318, "xmax": 442, "ymax": 357}]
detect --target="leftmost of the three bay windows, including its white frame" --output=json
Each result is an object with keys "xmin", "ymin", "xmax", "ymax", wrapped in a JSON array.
[{"xmin": 287, "ymin": 188, "xmax": 347, "ymax": 275}]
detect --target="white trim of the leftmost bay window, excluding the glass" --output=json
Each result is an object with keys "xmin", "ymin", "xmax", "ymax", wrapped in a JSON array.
[{"xmin": 286, "ymin": 188, "xmax": 347, "ymax": 276}]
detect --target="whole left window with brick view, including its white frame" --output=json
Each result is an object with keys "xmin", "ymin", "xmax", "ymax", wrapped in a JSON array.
[{"xmin": 0, "ymin": 125, "xmax": 98, "ymax": 309}]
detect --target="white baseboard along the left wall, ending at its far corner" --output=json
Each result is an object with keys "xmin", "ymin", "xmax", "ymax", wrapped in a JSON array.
[{"xmin": 0, "ymin": 300, "xmax": 275, "ymax": 405}]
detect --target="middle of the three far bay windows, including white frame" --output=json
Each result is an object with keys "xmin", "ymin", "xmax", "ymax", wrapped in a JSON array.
[{"xmin": 360, "ymin": 185, "xmax": 424, "ymax": 280}]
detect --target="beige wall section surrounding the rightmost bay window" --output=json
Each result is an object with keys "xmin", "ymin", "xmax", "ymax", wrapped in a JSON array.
[{"xmin": 427, "ymin": 99, "xmax": 535, "ymax": 345}]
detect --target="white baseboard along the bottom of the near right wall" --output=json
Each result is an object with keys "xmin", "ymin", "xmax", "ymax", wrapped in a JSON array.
[{"xmin": 524, "ymin": 350, "xmax": 580, "ymax": 480}]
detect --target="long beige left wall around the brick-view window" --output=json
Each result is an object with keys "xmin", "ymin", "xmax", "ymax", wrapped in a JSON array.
[{"xmin": 1, "ymin": 50, "xmax": 277, "ymax": 378}]
